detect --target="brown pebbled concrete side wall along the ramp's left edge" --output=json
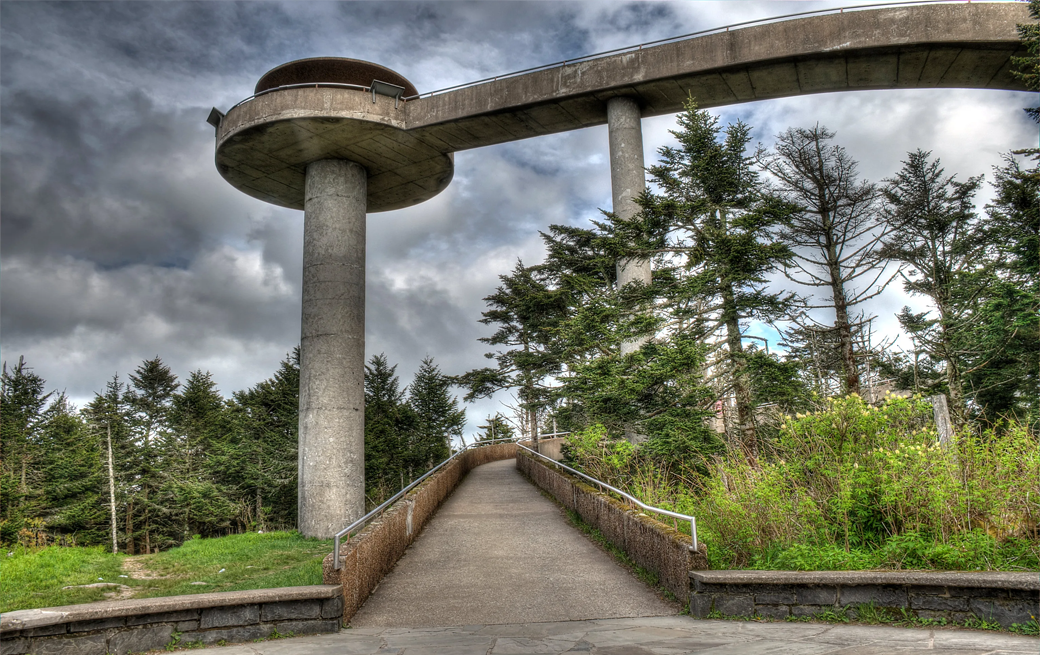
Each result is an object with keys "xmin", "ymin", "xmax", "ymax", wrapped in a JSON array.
[{"xmin": 321, "ymin": 443, "xmax": 517, "ymax": 621}]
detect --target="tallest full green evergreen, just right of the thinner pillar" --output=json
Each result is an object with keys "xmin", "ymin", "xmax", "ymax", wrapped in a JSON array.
[{"xmin": 638, "ymin": 100, "xmax": 795, "ymax": 456}]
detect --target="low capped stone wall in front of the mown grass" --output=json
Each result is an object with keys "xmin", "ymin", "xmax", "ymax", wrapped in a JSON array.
[{"xmin": 0, "ymin": 584, "xmax": 343, "ymax": 655}]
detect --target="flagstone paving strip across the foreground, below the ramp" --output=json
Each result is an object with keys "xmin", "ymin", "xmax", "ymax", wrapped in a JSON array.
[{"xmin": 204, "ymin": 617, "xmax": 1040, "ymax": 655}]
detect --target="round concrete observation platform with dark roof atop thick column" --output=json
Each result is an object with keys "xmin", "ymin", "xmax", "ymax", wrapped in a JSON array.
[{"xmin": 216, "ymin": 58, "xmax": 454, "ymax": 212}]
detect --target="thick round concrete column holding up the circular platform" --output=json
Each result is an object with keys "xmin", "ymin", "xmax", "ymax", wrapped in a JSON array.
[{"xmin": 298, "ymin": 159, "xmax": 368, "ymax": 539}]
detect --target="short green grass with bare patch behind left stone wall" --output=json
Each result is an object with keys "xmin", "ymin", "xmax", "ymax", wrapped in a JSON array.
[{"xmin": 0, "ymin": 532, "xmax": 332, "ymax": 611}]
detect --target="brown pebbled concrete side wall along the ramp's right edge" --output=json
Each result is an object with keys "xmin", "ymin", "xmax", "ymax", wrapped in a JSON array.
[{"xmin": 517, "ymin": 450, "xmax": 707, "ymax": 600}]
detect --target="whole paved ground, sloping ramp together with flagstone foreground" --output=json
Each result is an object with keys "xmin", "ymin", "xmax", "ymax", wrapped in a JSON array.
[{"xmin": 198, "ymin": 460, "xmax": 1040, "ymax": 655}]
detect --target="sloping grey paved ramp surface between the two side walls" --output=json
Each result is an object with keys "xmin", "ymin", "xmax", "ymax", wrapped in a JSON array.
[{"xmin": 350, "ymin": 460, "xmax": 678, "ymax": 628}]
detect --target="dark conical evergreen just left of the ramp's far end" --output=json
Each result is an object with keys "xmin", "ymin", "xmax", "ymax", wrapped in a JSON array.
[{"xmin": 408, "ymin": 357, "xmax": 466, "ymax": 471}]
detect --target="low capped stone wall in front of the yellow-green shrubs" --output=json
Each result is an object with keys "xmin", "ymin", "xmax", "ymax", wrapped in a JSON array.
[{"xmin": 690, "ymin": 571, "xmax": 1040, "ymax": 628}]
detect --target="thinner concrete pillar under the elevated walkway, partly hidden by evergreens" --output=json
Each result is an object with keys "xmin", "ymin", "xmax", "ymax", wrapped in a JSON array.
[{"xmin": 606, "ymin": 97, "xmax": 650, "ymax": 353}]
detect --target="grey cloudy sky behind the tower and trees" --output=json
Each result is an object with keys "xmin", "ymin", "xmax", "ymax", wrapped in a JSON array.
[{"xmin": 0, "ymin": 0, "xmax": 1037, "ymax": 440}]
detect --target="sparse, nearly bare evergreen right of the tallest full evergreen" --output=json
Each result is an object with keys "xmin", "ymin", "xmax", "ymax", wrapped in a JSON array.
[{"xmin": 758, "ymin": 125, "xmax": 891, "ymax": 393}]
